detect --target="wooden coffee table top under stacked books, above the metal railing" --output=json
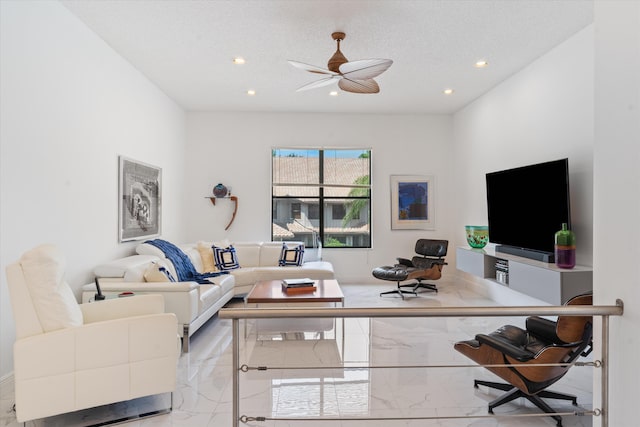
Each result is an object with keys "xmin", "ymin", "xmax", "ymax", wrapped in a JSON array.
[{"xmin": 245, "ymin": 279, "xmax": 344, "ymax": 307}]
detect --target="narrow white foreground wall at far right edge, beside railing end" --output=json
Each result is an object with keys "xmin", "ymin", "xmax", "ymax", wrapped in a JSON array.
[{"xmin": 593, "ymin": 1, "xmax": 640, "ymax": 426}]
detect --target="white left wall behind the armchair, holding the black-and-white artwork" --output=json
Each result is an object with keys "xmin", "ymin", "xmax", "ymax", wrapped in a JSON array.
[{"xmin": 0, "ymin": 1, "xmax": 186, "ymax": 377}]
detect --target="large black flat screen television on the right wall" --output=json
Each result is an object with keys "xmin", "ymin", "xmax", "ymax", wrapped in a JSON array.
[{"xmin": 486, "ymin": 159, "xmax": 571, "ymax": 262}]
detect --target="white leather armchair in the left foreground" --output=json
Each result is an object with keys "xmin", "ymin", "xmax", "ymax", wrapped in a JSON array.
[{"xmin": 7, "ymin": 245, "xmax": 179, "ymax": 422}]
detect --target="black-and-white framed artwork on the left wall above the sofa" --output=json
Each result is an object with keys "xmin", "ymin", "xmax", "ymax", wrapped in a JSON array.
[{"xmin": 118, "ymin": 156, "xmax": 162, "ymax": 242}]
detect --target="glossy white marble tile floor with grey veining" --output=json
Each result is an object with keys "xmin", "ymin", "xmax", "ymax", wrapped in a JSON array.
[{"xmin": 0, "ymin": 278, "xmax": 593, "ymax": 427}]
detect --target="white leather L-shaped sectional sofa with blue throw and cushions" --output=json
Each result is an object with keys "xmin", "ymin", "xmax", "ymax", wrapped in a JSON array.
[{"xmin": 82, "ymin": 242, "xmax": 334, "ymax": 352}]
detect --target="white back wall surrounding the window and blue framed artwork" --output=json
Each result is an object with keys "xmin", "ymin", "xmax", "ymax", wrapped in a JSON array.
[{"xmin": 185, "ymin": 112, "xmax": 456, "ymax": 282}]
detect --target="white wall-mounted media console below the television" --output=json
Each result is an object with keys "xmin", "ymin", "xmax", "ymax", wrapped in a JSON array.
[{"xmin": 456, "ymin": 246, "xmax": 593, "ymax": 305}]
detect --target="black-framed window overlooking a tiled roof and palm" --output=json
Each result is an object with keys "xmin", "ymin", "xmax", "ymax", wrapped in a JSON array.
[{"xmin": 271, "ymin": 148, "xmax": 371, "ymax": 248}]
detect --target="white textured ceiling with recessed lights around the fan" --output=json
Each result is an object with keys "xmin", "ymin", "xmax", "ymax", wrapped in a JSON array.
[{"xmin": 62, "ymin": 0, "xmax": 593, "ymax": 114}]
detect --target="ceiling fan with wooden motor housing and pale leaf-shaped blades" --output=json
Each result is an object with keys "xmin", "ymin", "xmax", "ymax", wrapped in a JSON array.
[{"xmin": 289, "ymin": 32, "xmax": 393, "ymax": 93}]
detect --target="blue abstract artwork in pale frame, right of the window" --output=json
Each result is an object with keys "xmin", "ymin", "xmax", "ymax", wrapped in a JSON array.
[{"xmin": 391, "ymin": 175, "xmax": 436, "ymax": 230}]
